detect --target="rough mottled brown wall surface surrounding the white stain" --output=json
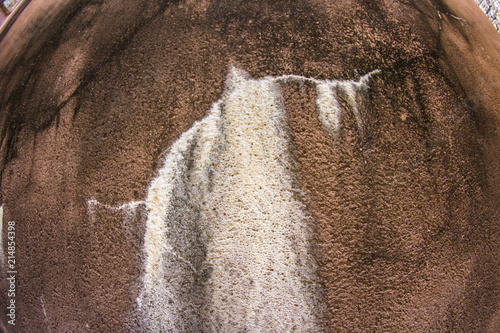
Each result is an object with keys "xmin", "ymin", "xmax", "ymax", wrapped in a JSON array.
[{"xmin": 0, "ymin": 0, "xmax": 500, "ymax": 332}]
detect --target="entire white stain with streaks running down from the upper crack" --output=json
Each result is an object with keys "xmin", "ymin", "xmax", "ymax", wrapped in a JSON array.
[{"xmin": 134, "ymin": 68, "xmax": 378, "ymax": 332}]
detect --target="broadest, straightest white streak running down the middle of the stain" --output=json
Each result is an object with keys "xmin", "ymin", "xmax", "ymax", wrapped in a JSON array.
[{"xmin": 206, "ymin": 71, "xmax": 320, "ymax": 332}]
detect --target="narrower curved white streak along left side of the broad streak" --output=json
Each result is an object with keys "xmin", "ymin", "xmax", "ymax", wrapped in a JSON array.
[{"xmin": 138, "ymin": 103, "xmax": 220, "ymax": 332}]
